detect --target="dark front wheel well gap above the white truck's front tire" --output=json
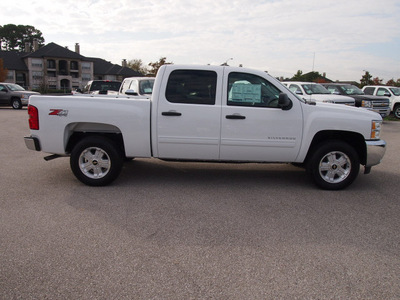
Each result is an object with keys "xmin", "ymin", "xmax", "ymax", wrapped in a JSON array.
[{"xmin": 305, "ymin": 130, "xmax": 367, "ymax": 165}]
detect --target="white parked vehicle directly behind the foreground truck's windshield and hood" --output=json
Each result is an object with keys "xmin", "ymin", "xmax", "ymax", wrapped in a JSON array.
[{"xmin": 283, "ymin": 81, "xmax": 355, "ymax": 106}]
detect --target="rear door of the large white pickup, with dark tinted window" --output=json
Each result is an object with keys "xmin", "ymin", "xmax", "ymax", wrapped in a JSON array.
[{"xmin": 153, "ymin": 66, "xmax": 223, "ymax": 160}]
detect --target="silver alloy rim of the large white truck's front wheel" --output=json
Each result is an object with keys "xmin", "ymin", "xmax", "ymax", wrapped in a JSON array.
[{"xmin": 319, "ymin": 151, "xmax": 351, "ymax": 183}]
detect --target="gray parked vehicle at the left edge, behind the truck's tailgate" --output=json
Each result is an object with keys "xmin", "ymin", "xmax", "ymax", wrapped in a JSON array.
[{"xmin": 0, "ymin": 82, "xmax": 40, "ymax": 109}]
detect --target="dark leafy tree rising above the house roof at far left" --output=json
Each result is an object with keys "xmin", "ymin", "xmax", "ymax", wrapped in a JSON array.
[{"xmin": 0, "ymin": 24, "xmax": 44, "ymax": 52}]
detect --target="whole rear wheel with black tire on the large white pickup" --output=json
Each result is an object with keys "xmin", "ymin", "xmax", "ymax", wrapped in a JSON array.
[{"xmin": 70, "ymin": 136, "xmax": 123, "ymax": 186}]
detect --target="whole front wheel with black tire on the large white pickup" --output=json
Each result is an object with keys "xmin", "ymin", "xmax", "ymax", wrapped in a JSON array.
[{"xmin": 307, "ymin": 141, "xmax": 360, "ymax": 190}]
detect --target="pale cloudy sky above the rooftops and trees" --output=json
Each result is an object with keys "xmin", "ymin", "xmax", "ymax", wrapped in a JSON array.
[{"xmin": 0, "ymin": 0, "xmax": 400, "ymax": 82}]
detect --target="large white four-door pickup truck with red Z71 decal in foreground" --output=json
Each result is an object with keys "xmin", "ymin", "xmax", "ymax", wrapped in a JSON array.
[{"xmin": 25, "ymin": 65, "xmax": 386, "ymax": 190}]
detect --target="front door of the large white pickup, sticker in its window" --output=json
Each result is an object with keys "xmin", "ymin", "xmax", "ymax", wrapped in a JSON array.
[{"xmin": 220, "ymin": 72, "xmax": 303, "ymax": 162}]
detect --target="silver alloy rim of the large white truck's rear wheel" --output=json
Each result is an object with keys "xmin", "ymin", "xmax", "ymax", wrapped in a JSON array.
[{"xmin": 79, "ymin": 147, "xmax": 111, "ymax": 179}]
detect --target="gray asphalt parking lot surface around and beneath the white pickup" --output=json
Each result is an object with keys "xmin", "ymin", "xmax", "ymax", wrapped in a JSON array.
[{"xmin": 0, "ymin": 107, "xmax": 400, "ymax": 299}]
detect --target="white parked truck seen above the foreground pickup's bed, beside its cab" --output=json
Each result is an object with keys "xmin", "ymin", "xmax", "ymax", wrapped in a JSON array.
[{"xmin": 119, "ymin": 77, "xmax": 155, "ymax": 98}]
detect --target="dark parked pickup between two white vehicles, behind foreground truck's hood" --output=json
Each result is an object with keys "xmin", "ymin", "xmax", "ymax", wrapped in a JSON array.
[{"xmin": 321, "ymin": 83, "xmax": 390, "ymax": 118}]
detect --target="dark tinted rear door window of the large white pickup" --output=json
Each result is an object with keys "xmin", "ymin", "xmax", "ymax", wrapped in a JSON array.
[{"xmin": 165, "ymin": 70, "xmax": 217, "ymax": 105}]
